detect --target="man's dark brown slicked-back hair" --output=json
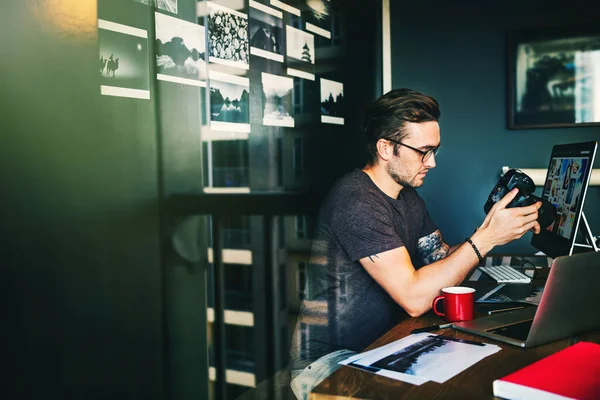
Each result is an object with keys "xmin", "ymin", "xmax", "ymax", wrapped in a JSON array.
[{"xmin": 363, "ymin": 88, "xmax": 440, "ymax": 165}]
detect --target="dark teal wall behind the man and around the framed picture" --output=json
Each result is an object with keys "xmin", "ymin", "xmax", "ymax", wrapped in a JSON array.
[{"xmin": 391, "ymin": 0, "xmax": 600, "ymax": 254}]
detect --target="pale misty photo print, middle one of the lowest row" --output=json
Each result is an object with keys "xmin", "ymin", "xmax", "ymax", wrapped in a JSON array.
[{"xmin": 262, "ymin": 72, "xmax": 294, "ymax": 128}]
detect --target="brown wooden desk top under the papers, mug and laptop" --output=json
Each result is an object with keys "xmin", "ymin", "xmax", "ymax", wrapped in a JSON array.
[{"xmin": 310, "ymin": 304, "xmax": 600, "ymax": 400}]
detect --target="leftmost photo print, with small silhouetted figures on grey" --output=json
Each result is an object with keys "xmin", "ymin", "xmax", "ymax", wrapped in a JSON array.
[{"xmin": 98, "ymin": 19, "xmax": 150, "ymax": 100}]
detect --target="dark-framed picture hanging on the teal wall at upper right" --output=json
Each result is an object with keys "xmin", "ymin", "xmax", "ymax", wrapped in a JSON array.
[{"xmin": 508, "ymin": 24, "xmax": 600, "ymax": 129}]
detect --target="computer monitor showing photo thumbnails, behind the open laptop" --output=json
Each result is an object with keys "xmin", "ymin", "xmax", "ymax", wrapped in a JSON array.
[{"xmin": 531, "ymin": 142, "xmax": 598, "ymax": 258}]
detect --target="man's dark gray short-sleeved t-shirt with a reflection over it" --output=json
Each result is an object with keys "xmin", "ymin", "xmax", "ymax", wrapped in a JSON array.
[{"xmin": 292, "ymin": 169, "xmax": 437, "ymax": 369}]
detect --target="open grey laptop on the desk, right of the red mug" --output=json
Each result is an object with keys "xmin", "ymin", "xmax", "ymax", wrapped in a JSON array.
[{"xmin": 454, "ymin": 252, "xmax": 600, "ymax": 347}]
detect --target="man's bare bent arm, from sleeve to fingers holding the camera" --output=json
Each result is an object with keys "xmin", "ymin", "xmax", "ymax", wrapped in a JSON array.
[{"xmin": 360, "ymin": 190, "xmax": 541, "ymax": 317}]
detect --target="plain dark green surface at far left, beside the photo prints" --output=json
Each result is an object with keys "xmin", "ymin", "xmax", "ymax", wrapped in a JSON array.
[{"xmin": 0, "ymin": 0, "xmax": 164, "ymax": 399}]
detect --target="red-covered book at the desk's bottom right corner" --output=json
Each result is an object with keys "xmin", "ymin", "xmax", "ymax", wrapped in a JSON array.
[{"xmin": 493, "ymin": 342, "xmax": 600, "ymax": 400}]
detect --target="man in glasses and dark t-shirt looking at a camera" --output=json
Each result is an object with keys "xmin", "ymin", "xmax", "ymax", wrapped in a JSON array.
[{"xmin": 292, "ymin": 89, "xmax": 541, "ymax": 399}]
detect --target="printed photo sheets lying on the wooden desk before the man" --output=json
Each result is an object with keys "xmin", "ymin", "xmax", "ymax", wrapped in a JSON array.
[{"xmin": 340, "ymin": 333, "xmax": 501, "ymax": 385}]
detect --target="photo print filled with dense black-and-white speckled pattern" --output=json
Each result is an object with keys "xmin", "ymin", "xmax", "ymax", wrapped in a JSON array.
[{"xmin": 207, "ymin": 2, "xmax": 250, "ymax": 69}]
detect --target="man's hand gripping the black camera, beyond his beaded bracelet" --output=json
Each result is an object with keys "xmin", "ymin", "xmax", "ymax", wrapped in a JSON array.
[{"xmin": 480, "ymin": 189, "xmax": 542, "ymax": 247}]
